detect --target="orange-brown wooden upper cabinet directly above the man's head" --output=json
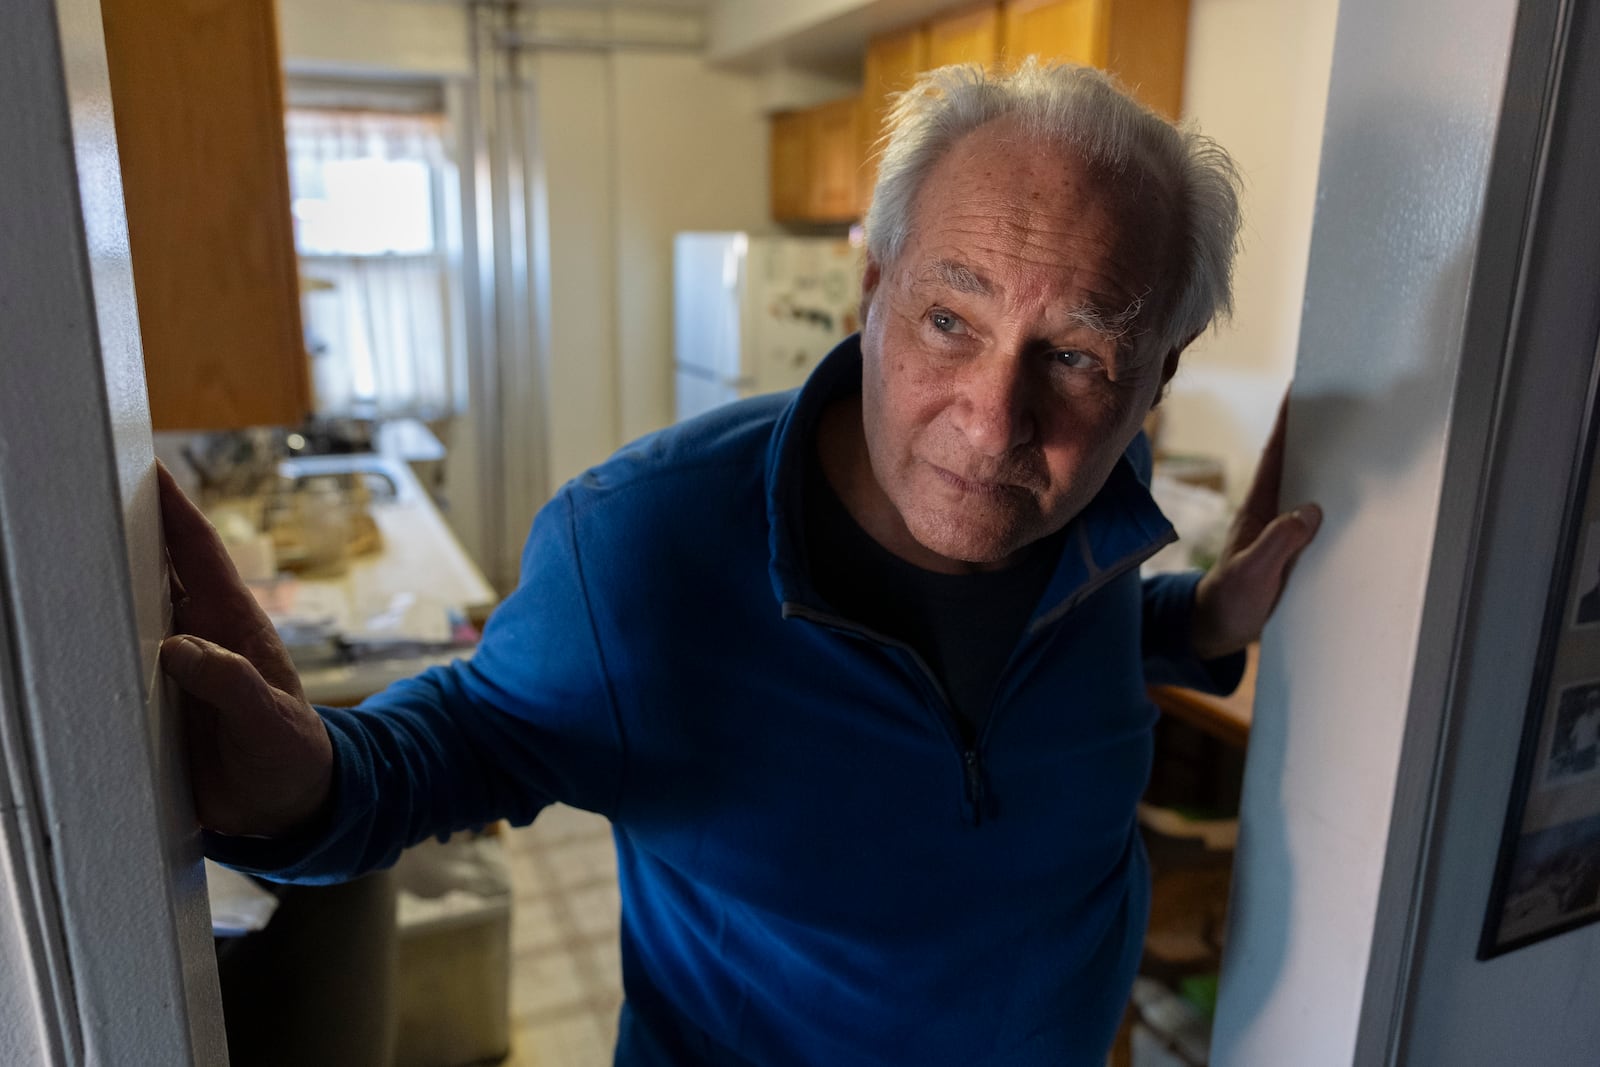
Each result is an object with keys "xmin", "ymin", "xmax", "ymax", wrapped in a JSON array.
[{"xmin": 1002, "ymin": 0, "xmax": 1189, "ymax": 120}]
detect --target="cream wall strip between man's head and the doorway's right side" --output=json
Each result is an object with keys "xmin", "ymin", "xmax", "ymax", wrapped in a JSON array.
[{"xmin": 1160, "ymin": 0, "xmax": 1339, "ymax": 501}]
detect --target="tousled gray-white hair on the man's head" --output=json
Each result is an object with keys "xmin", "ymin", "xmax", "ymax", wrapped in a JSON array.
[{"xmin": 867, "ymin": 58, "xmax": 1240, "ymax": 350}]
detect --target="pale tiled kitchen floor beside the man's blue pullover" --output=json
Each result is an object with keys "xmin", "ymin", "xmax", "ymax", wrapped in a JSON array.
[{"xmin": 504, "ymin": 806, "xmax": 622, "ymax": 1067}]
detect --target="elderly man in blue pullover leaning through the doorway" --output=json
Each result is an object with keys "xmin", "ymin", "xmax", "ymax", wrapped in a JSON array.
[{"xmin": 163, "ymin": 66, "xmax": 1317, "ymax": 1065}]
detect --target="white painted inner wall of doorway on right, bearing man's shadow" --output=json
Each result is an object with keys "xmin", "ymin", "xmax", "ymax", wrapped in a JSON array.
[{"xmin": 1213, "ymin": 0, "xmax": 1552, "ymax": 1067}]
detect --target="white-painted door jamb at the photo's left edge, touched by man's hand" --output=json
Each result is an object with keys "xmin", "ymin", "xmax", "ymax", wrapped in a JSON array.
[{"xmin": 0, "ymin": 0, "xmax": 227, "ymax": 1065}]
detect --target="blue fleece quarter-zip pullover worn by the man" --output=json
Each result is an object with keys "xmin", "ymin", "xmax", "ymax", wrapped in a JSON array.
[{"xmin": 208, "ymin": 338, "xmax": 1240, "ymax": 1067}]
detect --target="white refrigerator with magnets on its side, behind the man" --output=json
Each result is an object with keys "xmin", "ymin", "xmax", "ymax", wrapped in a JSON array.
[{"xmin": 674, "ymin": 234, "xmax": 864, "ymax": 421}]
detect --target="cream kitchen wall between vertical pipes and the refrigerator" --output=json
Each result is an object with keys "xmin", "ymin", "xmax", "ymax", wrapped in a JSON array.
[{"xmin": 534, "ymin": 50, "xmax": 770, "ymax": 488}]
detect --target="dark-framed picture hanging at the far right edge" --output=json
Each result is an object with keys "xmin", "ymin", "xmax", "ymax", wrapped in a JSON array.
[{"xmin": 1478, "ymin": 347, "xmax": 1600, "ymax": 960}]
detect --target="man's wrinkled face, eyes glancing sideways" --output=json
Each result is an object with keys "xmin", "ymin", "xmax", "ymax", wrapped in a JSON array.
[{"xmin": 861, "ymin": 122, "xmax": 1176, "ymax": 569}]
